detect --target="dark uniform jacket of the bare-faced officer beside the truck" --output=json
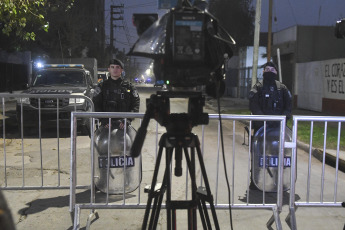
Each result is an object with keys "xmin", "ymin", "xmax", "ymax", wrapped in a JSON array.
[{"xmin": 93, "ymin": 78, "xmax": 140, "ymax": 125}]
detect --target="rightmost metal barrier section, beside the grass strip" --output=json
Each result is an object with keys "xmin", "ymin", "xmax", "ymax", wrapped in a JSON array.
[{"xmin": 286, "ymin": 116, "xmax": 345, "ymax": 229}]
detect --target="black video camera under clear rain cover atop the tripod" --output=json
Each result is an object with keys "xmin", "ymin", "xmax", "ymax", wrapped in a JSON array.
[{"xmin": 128, "ymin": 1, "xmax": 235, "ymax": 88}]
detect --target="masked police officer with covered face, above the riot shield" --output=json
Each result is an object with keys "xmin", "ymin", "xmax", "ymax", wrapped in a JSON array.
[{"xmin": 249, "ymin": 62, "xmax": 291, "ymax": 133}]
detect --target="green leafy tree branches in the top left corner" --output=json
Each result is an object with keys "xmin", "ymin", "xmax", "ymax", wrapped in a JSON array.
[{"xmin": 0, "ymin": 0, "xmax": 74, "ymax": 50}]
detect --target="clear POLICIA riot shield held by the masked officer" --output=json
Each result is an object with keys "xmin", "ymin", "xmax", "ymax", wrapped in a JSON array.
[{"xmin": 252, "ymin": 126, "xmax": 292, "ymax": 192}]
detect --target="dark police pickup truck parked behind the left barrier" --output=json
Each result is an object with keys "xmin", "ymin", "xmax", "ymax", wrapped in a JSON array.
[{"xmin": 16, "ymin": 65, "xmax": 97, "ymax": 133}]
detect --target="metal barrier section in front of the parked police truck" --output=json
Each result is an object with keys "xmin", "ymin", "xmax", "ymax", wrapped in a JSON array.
[{"xmin": 0, "ymin": 93, "xmax": 94, "ymax": 190}]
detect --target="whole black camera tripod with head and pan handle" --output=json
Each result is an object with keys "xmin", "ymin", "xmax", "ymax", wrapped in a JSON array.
[{"xmin": 131, "ymin": 92, "xmax": 219, "ymax": 230}]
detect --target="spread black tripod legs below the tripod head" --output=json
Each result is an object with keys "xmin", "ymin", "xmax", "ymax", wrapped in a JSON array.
[{"xmin": 142, "ymin": 124, "xmax": 219, "ymax": 229}]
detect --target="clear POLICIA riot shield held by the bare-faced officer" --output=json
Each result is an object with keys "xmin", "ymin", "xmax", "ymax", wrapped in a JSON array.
[{"xmin": 93, "ymin": 125, "xmax": 141, "ymax": 194}]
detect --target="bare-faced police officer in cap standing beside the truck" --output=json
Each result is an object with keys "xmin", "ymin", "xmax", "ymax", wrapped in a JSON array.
[{"xmin": 93, "ymin": 59, "xmax": 140, "ymax": 129}]
